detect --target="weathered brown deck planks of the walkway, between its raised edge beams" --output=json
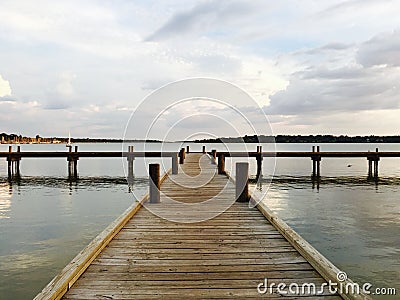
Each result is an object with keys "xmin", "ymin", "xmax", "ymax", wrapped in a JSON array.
[{"xmin": 60, "ymin": 153, "xmax": 344, "ymax": 299}]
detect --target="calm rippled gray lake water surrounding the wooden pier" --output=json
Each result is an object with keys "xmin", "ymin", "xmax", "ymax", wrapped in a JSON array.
[{"xmin": 0, "ymin": 143, "xmax": 400, "ymax": 299}]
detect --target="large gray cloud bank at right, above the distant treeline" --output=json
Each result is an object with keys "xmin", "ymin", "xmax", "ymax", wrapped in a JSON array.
[{"xmin": 266, "ymin": 33, "xmax": 400, "ymax": 115}]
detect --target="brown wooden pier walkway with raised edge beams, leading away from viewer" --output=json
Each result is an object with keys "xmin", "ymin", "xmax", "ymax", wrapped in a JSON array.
[{"xmin": 35, "ymin": 149, "xmax": 369, "ymax": 300}]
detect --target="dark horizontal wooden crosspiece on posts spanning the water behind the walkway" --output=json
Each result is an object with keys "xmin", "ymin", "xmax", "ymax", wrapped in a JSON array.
[{"xmin": 0, "ymin": 146, "xmax": 400, "ymax": 180}]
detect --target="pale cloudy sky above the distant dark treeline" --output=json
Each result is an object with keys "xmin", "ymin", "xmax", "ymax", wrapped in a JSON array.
[{"xmin": 0, "ymin": 0, "xmax": 400, "ymax": 138}]
